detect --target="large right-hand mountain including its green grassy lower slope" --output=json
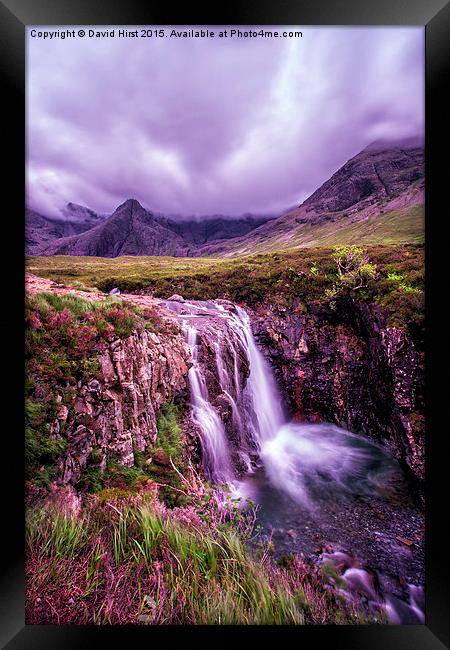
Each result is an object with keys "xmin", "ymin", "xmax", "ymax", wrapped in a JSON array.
[{"xmin": 202, "ymin": 138, "xmax": 424, "ymax": 256}]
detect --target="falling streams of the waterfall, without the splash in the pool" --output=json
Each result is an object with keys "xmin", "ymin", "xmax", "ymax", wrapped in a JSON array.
[{"xmin": 183, "ymin": 303, "xmax": 284, "ymax": 483}]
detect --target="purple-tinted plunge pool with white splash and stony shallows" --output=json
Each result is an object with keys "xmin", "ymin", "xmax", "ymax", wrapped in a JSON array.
[{"xmin": 237, "ymin": 423, "xmax": 424, "ymax": 624}]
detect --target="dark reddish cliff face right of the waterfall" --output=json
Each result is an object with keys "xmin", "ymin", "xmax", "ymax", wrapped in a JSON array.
[{"xmin": 248, "ymin": 299, "xmax": 424, "ymax": 485}]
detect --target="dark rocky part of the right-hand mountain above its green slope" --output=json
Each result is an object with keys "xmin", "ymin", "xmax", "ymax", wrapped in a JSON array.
[{"xmin": 200, "ymin": 139, "xmax": 424, "ymax": 255}]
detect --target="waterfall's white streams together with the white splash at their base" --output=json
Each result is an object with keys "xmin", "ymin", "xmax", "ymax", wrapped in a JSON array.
[{"xmin": 183, "ymin": 303, "xmax": 400, "ymax": 509}]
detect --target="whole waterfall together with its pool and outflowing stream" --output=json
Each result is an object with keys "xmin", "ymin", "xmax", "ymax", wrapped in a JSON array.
[{"xmin": 163, "ymin": 301, "xmax": 423, "ymax": 623}]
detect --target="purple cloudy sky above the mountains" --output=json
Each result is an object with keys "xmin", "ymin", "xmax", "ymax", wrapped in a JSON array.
[{"xmin": 27, "ymin": 26, "xmax": 424, "ymax": 215}]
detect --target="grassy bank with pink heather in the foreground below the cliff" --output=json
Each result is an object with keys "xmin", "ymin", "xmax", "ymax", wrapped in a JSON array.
[{"xmin": 26, "ymin": 485, "xmax": 372, "ymax": 624}]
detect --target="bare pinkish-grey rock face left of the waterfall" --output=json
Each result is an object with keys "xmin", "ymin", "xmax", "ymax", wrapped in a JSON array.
[{"xmin": 52, "ymin": 322, "xmax": 190, "ymax": 484}]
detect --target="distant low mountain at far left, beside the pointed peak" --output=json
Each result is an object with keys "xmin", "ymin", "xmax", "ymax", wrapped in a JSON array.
[{"xmin": 25, "ymin": 203, "xmax": 105, "ymax": 255}]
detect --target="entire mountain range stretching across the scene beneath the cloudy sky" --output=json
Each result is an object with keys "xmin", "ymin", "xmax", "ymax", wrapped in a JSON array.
[{"xmin": 27, "ymin": 138, "xmax": 424, "ymax": 257}]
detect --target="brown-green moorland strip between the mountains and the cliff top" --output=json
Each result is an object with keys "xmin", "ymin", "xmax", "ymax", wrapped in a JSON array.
[{"xmin": 28, "ymin": 244, "xmax": 424, "ymax": 337}]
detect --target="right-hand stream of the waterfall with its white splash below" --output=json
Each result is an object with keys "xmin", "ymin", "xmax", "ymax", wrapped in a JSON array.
[{"xmin": 221, "ymin": 307, "xmax": 404, "ymax": 509}]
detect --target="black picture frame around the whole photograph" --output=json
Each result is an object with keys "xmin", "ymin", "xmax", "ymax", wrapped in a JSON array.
[{"xmin": 0, "ymin": 0, "xmax": 450, "ymax": 650}]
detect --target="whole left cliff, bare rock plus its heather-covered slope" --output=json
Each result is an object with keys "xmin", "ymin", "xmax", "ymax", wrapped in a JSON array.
[{"xmin": 26, "ymin": 274, "xmax": 191, "ymax": 484}]
